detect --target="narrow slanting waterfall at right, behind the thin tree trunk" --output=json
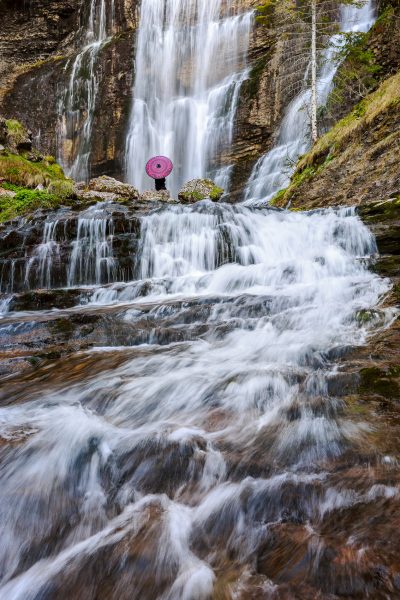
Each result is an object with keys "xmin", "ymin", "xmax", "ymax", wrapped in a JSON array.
[{"xmin": 245, "ymin": 0, "xmax": 374, "ymax": 203}]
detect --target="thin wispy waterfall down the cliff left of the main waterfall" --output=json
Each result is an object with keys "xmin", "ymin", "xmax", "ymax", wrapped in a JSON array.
[{"xmin": 58, "ymin": 0, "xmax": 115, "ymax": 181}]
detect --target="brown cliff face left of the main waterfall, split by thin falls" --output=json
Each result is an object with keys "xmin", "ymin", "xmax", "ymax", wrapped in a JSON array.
[{"xmin": 0, "ymin": 0, "xmax": 137, "ymax": 182}]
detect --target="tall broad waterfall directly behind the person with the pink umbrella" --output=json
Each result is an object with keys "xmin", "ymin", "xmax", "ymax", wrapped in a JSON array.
[{"xmin": 126, "ymin": 0, "xmax": 253, "ymax": 194}]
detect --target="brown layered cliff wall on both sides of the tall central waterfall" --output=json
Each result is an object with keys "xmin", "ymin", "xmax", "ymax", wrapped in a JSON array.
[{"xmin": 0, "ymin": 0, "xmax": 310, "ymax": 190}]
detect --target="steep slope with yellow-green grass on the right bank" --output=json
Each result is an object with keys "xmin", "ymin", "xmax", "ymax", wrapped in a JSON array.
[{"xmin": 273, "ymin": 73, "xmax": 400, "ymax": 209}]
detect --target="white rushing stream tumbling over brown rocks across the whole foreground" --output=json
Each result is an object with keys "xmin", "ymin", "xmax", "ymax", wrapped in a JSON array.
[{"xmin": 0, "ymin": 201, "xmax": 399, "ymax": 600}]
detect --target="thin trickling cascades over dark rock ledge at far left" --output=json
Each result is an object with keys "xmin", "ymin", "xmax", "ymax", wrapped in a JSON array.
[{"xmin": 0, "ymin": 203, "xmax": 126, "ymax": 294}]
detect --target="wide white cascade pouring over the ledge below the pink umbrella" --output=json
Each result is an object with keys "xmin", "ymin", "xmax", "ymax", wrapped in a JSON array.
[{"xmin": 86, "ymin": 202, "xmax": 382, "ymax": 304}]
